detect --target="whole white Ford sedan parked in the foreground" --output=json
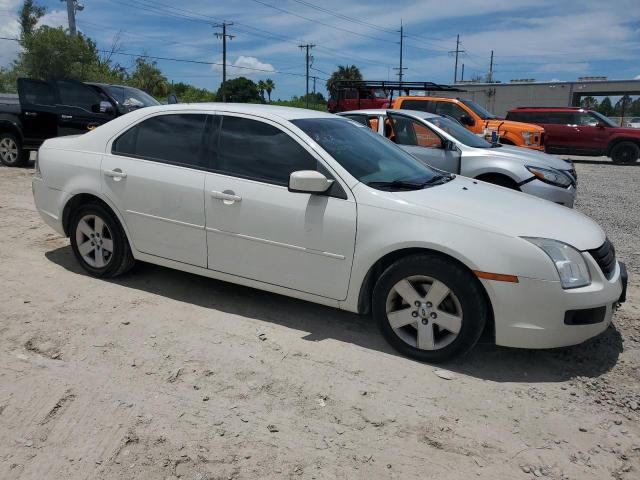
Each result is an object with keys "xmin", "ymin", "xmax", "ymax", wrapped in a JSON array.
[{"xmin": 33, "ymin": 104, "xmax": 626, "ymax": 362}]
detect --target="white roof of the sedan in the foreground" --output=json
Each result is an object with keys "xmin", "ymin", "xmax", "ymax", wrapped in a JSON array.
[{"xmin": 122, "ymin": 102, "xmax": 335, "ymax": 120}]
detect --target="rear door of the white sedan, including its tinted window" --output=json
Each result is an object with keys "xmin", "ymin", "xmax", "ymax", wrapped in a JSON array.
[{"xmin": 102, "ymin": 113, "xmax": 213, "ymax": 268}]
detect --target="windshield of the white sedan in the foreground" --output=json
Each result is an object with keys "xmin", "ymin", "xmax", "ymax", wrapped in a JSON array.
[{"xmin": 292, "ymin": 118, "xmax": 449, "ymax": 190}]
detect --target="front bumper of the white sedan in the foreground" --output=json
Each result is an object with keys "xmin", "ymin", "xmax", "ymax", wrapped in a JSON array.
[{"xmin": 481, "ymin": 254, "xmax": 627, "ymax": 348}]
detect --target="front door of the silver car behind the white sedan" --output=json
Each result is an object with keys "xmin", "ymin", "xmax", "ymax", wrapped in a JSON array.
[{"xmin": 385, "ymin": 111, "xmax": 460, "ymax": 173}]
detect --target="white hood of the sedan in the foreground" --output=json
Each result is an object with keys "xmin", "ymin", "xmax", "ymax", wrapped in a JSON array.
[{"xmin": 392, "ymin": 176, "xmax": 605, "ymax": 250}]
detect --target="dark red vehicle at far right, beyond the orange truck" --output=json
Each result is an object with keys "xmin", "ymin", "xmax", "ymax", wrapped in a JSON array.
[{"xmin": 507, "ymin": 107, "xmax": 640, "ymax": 163}]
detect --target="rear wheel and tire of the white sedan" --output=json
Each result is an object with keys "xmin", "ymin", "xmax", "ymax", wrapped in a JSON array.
[{"xmin": 69, "ymin": 203, "xmax": 135, "ymax": 278}]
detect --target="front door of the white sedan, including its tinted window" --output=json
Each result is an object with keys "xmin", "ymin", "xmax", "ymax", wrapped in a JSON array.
[{"xmin": 205, "ymin": 114, "xmax": 356, "ymax": 300}]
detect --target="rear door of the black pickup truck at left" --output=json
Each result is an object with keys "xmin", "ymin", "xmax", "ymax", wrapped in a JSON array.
[{"xmin": 18, "ymin": 78, "xmax": 58, "ymax": 145}]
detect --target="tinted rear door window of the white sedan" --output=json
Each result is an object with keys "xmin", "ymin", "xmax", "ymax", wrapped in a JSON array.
[{"xmin": 112, "ymin": 114, "xmax": 209, "ymax": 168}]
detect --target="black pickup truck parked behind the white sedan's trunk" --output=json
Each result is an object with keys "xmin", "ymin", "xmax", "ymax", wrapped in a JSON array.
[{"xmin": 0, "ymin": 78, "xmax": 160, "ymax": 167}]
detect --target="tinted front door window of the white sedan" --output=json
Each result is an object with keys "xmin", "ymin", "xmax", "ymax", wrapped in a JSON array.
[{"xmin": 216, "ymin": 116, "xmax": 318, "ymax": 185}]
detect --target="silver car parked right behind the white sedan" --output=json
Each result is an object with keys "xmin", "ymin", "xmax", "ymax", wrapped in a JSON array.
[{"xmin": 339, "ymin": 110, "xmax": 577, "ymax": 207}]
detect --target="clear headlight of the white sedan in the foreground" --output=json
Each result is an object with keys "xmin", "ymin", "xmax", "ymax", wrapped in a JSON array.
[{"xmin": 522, "ymin": 237, "xmax": 591, "ymax": 289}]
